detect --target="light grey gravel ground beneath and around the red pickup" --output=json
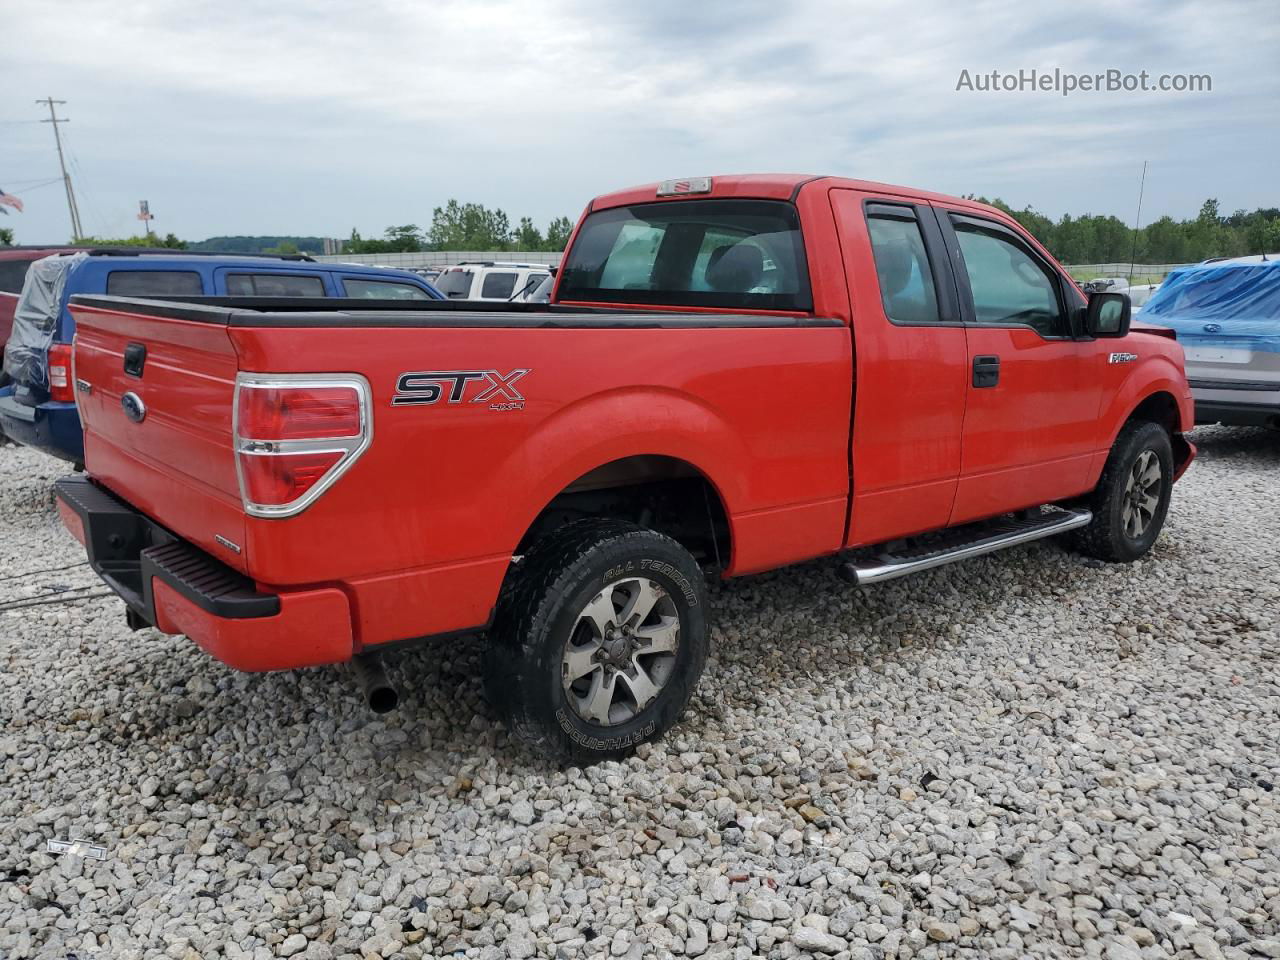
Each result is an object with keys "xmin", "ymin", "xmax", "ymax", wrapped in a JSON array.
[{"xmin": 0, "ymin": 429, "xmax": 1280, "ymax": 960}]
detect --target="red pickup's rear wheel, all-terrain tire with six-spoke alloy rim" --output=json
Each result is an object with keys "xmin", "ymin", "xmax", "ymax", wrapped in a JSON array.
[{"xmin": 485, "ymin": 520, "xmax": 708, "ymax": 764}]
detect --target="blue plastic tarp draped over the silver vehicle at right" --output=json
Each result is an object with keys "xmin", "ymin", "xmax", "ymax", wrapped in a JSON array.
[{"xmin": 1140, "ymin": 260, "xmax": 1280, "ymax": 353}]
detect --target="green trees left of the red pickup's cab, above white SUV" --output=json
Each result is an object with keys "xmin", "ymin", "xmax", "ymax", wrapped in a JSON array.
[{"xmin": 343, "ymin": 200, "xmax": 573, "ymax": 253}]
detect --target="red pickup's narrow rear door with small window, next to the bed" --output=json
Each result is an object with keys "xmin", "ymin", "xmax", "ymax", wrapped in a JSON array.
[{"xmin": 831, "ymin": 189, "xmax": 969, "ymax": 545}]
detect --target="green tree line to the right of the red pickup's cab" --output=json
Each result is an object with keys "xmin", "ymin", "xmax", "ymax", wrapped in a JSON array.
[{"xmin": 969, "ymin": 196, "xmax": 1280, "ymax": 264}]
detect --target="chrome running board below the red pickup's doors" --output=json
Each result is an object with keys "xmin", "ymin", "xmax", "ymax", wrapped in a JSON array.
[{"xmin": 840, "ymin": 509, "xmax": 1093, "ymax": 586}]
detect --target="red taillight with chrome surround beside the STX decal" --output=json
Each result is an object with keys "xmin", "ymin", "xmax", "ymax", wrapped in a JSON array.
[{"xmin": 232, "ymin": 374, "xmax": 374, "ymax": 517}]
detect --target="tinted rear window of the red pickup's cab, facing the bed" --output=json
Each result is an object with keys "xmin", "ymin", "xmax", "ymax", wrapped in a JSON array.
[{"xmin": 559, "ymin": 200, "xmax": 813, "ymax": 311}]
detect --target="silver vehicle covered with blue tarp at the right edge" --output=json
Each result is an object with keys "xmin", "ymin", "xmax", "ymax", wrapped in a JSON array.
[{"xmin": 1142, "ymin": 255, "xmax": 1280, "ymax": 428}]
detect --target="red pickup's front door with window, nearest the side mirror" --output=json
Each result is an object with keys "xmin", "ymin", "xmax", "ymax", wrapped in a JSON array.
[{"xmin": 937, "ymin": 207, "xmax": 1101, "ymax": 524}]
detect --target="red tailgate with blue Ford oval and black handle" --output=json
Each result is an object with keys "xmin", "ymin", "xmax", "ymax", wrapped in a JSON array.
[{"xmin": 70, "ymin": 297, "xmax": 248, "ymax": 571}]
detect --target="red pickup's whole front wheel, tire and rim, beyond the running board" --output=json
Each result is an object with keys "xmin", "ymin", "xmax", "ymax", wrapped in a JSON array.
[{"xmin": 1075, "ymin": 421, "xmax": 1174, "ymax": 563}]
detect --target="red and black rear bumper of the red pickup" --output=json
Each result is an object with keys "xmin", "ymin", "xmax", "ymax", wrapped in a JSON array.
[{"xmin": 54, "ymin": 476, "xmax": 353, "ymax": 671}]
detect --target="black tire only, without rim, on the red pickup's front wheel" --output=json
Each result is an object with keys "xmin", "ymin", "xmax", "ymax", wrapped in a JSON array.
[{"xmin": 1071, "ymin": 420, "xmax": 1174, "ymax": 563}]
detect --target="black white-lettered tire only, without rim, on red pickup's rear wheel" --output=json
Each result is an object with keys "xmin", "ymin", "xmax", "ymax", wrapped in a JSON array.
[{"xmin": 484, "ymin": 520, "xmax": 708, "ymax": 765}]
